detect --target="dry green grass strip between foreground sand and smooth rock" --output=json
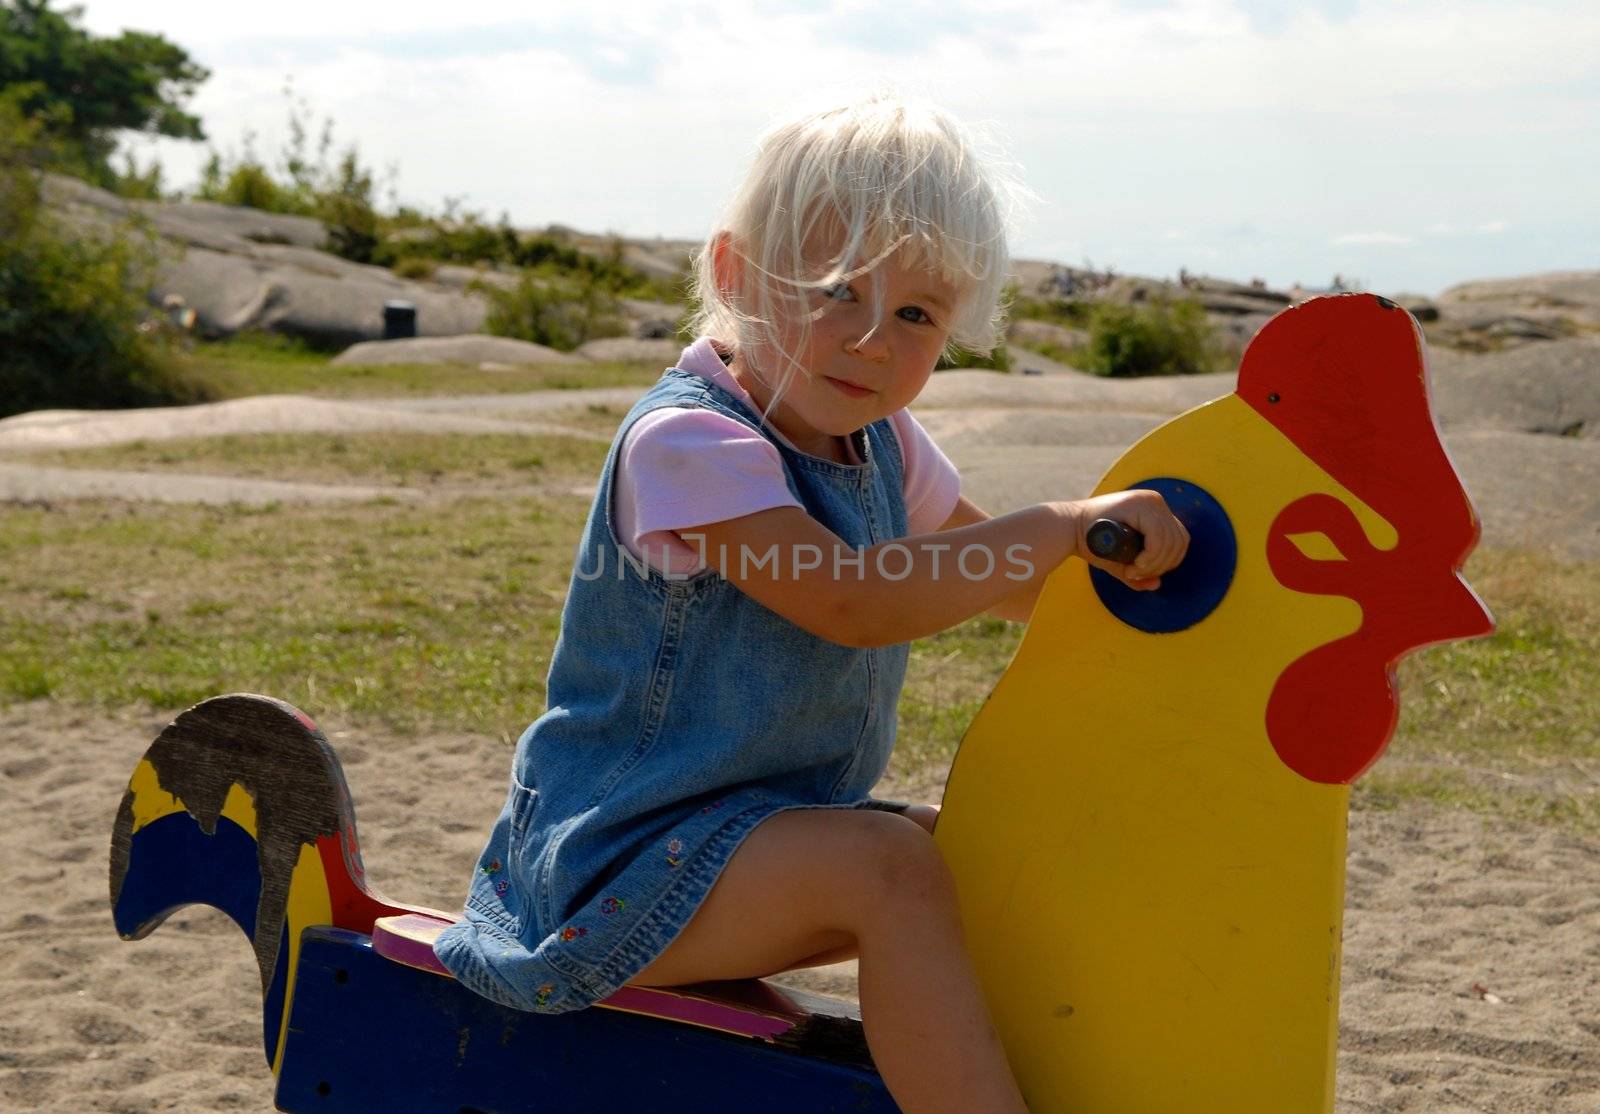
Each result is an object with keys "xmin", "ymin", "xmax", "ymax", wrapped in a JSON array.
[{"xmin": 0, "ymin": 480, "xmax": 1600, "ymax": 831}]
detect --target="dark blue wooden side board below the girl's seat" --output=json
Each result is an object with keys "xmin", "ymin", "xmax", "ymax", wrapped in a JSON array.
[{"xmin": 277, "ymin": 928, "xmax": 899, "ymax": 1114}]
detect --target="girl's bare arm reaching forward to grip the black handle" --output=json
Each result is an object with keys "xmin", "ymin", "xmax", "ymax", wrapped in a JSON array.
[{"xmin": 678, "ymin": 490, "xmax": 1189, "ymax": 647}]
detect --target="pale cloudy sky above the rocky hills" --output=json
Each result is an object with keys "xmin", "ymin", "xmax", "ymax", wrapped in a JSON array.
[{"xmin": 82, "ymin": 0, "xmax": 1600, "ymax": 295}]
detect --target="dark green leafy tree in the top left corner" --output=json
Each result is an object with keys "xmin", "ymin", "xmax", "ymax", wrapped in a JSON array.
[{"xmin": 0, "ymin": 0, "xmax": 210, "ymax": 187}]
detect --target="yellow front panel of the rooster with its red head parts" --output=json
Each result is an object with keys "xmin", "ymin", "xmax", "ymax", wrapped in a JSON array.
[{"xmin": 936, "ymin": 296, "xmax": 1488, "ymax": 1114}]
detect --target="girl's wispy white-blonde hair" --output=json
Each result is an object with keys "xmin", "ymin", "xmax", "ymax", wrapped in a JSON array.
[{"xmin": 691, "ymin": 93, "xmax": 1026, "ymax": 403}]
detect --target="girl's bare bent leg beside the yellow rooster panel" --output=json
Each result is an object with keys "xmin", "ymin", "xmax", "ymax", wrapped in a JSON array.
[{"xmin": 634, "ymin": 810, "xmax": 1027, "ymax": 1114}]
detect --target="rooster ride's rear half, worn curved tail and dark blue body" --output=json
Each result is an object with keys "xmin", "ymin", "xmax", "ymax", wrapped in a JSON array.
[{"xmin": 110, "ymin": 695, "xmax": 896, "ymax": 1114}]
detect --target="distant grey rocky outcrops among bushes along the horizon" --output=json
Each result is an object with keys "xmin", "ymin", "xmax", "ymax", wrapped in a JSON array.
[{"xmin": 45, "ymin": 176, "xmax": 1600, "ymax": 361}]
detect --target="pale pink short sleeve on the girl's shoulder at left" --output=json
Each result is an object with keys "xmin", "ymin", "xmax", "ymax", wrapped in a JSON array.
[{"xmin": 613, "ymin": 407, "xmax": 800, "ymax": 575}]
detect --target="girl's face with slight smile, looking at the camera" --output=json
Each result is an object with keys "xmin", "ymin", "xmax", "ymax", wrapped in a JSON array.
[{"xmin": 734, "ymin": 241, "xmax": 958, "ymax": 458}]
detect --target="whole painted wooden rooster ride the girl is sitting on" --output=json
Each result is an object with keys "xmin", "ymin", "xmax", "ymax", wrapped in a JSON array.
[{"xmin": 110, "ymin": 295, "xmax": 1491, "ymax": 1114}]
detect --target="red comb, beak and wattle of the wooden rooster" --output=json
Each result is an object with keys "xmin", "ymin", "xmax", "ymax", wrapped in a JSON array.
[{"xmin": 1238, "ymin": 295, "xmax": 1493, "ymax": 783}]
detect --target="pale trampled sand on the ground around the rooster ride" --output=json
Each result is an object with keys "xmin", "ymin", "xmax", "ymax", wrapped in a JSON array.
[{"xmin": 0, "ymin": 701, "xmax": 1600, "ymax": 1114}]
